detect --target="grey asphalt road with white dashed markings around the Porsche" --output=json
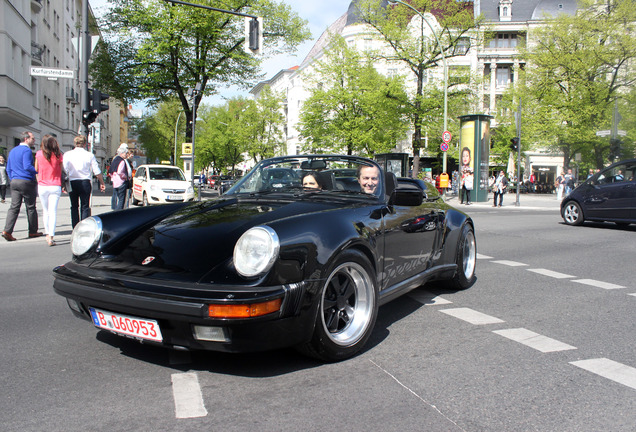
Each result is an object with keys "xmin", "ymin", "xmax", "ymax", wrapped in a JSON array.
[{"xmin": 0, "ymin": 190, "xmax": 636, "ymax": 432}]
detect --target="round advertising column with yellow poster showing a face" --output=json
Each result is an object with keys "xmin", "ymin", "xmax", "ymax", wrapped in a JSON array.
[{"xmin": 459, "ymin": 114, "xmax": 493, "ymax": 202}]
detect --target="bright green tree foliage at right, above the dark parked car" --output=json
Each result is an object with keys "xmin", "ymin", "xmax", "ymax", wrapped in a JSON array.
[{"xmin": 515, "ymin": 0, "xmax": 636, "ymax": 168}]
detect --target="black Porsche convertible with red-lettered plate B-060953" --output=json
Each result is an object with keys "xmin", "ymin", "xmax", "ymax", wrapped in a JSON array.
[{"xmin": 53, "ymin": 155, "xmax": 476, "ymax": 361}]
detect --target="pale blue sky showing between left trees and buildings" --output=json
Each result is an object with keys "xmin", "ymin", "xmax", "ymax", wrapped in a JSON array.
[{"xmin": 89, "ymin": 0, "xmax": 350, "ymax": 110}]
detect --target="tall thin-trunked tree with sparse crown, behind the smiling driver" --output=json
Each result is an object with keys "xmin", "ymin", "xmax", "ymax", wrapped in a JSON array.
[{"xmin": 358, "ymin": 0, "xmax": 479, "ymax": 176}]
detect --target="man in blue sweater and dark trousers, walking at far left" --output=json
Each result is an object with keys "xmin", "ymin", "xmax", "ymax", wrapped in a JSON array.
[{"xmin": 2, "ymin": 131, "xmax": 44, "ymax": 241}]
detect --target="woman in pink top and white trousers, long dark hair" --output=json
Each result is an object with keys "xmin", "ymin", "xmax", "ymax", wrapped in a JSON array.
[{"xmin": 35, "ymin": 135, "xmax": 62, "ymax": 246}]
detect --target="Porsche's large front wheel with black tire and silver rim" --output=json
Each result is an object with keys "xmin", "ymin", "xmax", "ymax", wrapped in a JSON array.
[{"xmin": 298, "ymin": 250, "xmax": 378, "ymax": 362}]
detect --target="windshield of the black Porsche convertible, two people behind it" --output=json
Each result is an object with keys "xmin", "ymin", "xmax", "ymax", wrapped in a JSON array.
[{"xmin": 227, "ymin": 155, "xmax": 384, "ymax": 196}]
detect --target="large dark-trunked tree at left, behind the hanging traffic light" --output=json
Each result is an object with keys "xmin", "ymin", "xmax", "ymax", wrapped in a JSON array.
[{"xmin": 91, "ymin": 0, "xmax": 310, "ymax": 138}]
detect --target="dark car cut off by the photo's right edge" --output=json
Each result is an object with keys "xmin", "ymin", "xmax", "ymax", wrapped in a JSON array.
[{"xmin": 561, "ymin": 159, "xmax": 636, "ymax": 225}]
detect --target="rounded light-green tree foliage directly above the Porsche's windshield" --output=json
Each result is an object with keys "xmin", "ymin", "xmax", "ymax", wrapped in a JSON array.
[{"xmin": 299, "ymin": 36, "xmax": 407, "ymax": 156}]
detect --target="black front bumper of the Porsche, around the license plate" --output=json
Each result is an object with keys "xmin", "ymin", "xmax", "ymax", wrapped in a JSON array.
[{"xmin": 53, "ymin": 266, "xmax": 317, "ymax": 352}]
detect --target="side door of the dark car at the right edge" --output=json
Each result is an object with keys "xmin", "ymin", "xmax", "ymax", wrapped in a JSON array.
[{"xmin": 583, "ymin": 164, "xmax": 636, "ymax": 220}]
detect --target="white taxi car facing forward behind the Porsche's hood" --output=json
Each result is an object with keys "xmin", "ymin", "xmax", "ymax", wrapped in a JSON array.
[{"xmin": 131, "ymin": 165, "xmax": 194, "ymax": 206}]
